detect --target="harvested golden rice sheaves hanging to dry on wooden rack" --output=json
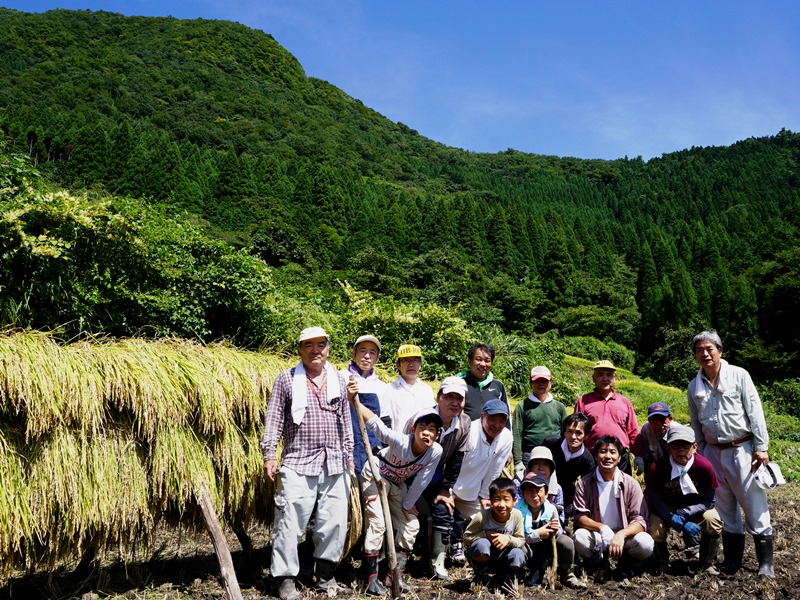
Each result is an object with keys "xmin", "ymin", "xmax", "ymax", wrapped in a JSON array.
[{"xmin": 0, "ymin": 331, "xmax": 361, "ymax": 582}]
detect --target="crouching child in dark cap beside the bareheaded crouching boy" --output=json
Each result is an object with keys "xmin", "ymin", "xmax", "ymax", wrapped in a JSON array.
[{"xmin": 517, "ymin": 471, "xmax": 586, "ymax": 588}]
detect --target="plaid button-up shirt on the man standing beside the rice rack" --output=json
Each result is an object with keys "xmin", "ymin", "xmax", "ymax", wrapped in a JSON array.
[{"xmin": 261, "ymin": 368, "xmax": 353, "ymax": 476}]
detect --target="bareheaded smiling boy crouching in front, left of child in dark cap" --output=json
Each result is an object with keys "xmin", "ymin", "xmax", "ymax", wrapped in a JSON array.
[{"xmin": 464, "ymin": 477, "xmax": 526, "ymax": 585}]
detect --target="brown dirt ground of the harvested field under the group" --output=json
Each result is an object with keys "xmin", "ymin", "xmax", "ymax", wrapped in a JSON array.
[{"xmin": 0, "ymin": 483, "xmax": 800, "ymax": 600}]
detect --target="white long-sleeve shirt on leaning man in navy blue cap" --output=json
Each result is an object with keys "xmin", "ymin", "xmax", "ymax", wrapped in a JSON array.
[{"xmin": 453, "ymin": 419, "xmax": 514, "ymax": 502}]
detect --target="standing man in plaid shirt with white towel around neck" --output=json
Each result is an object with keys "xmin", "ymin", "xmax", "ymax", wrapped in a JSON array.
[{"xmin": 261, "ymin": 327, "xmax": 353, "ymax": 600}]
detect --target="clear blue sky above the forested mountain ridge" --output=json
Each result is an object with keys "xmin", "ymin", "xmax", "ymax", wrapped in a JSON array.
[{"xmin": 0, "ymin": 0, "xmax": 800, "ymax": 159}]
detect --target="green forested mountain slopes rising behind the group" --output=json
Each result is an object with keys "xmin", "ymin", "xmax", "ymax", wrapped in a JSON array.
[{"xmin": 0, "ymin": 9, "xmax": 800, "ymax": 384}]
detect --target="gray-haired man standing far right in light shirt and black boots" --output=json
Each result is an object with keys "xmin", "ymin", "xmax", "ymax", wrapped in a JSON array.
[{"xmin": 688, "ymin": 331, "xmax": 775, "ymax": 578}]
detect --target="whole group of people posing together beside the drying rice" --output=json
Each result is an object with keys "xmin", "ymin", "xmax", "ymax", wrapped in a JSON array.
[{"xmin": 261, "ymin": 327, "xmax": 774, "ymax": 600}]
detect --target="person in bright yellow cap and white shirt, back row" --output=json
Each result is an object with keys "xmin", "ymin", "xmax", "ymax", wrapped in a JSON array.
[{"xmin": 389, "ymin": 344, "xmax": 436, "ymax": 433}]
